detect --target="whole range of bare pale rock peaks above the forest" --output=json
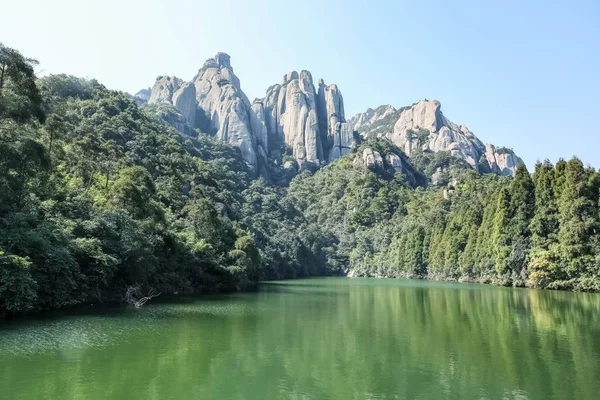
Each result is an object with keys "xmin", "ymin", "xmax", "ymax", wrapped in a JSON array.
[{"xmin": 135, "ymin": 53, "xmax": 522, "ymax": 178}]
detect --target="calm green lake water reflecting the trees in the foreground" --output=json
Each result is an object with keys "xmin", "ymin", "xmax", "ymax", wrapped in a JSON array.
[{"xmin": 0, "ymin": 278, "xmax": 600, "ymax": 400}]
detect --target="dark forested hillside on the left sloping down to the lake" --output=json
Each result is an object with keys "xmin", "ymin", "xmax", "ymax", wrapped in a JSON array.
[{"xmin": 0, "ymin": 46, "xmax": 335, "ymax": 315}]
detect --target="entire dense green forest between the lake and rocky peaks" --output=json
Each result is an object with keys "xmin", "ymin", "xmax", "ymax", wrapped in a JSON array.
[{"xmin": 0, "ymin": 45, "xmax": 600, "ymax": 315}]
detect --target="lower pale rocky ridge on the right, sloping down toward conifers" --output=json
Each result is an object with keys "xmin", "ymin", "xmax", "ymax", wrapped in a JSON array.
[{"xmin": 351, "ymin": 100, "xmax": 522, "ymax": 175}]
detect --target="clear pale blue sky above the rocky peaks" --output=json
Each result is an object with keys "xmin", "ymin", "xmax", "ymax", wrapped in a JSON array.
[{"xmin": 0, "ymin": 0, "xmax": 600, "ymax": 168}]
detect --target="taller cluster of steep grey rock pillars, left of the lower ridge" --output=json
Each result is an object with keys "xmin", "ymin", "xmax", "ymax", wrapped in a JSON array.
[{"xmin": 141, "ymin": 53, "xmax": 356, "ymax": 177}]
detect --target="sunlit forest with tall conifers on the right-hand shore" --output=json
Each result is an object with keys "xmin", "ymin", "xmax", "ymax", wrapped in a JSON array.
[{"xmin": 290, "ymin": 142, "xmax": 600, "ymax": 291}]
